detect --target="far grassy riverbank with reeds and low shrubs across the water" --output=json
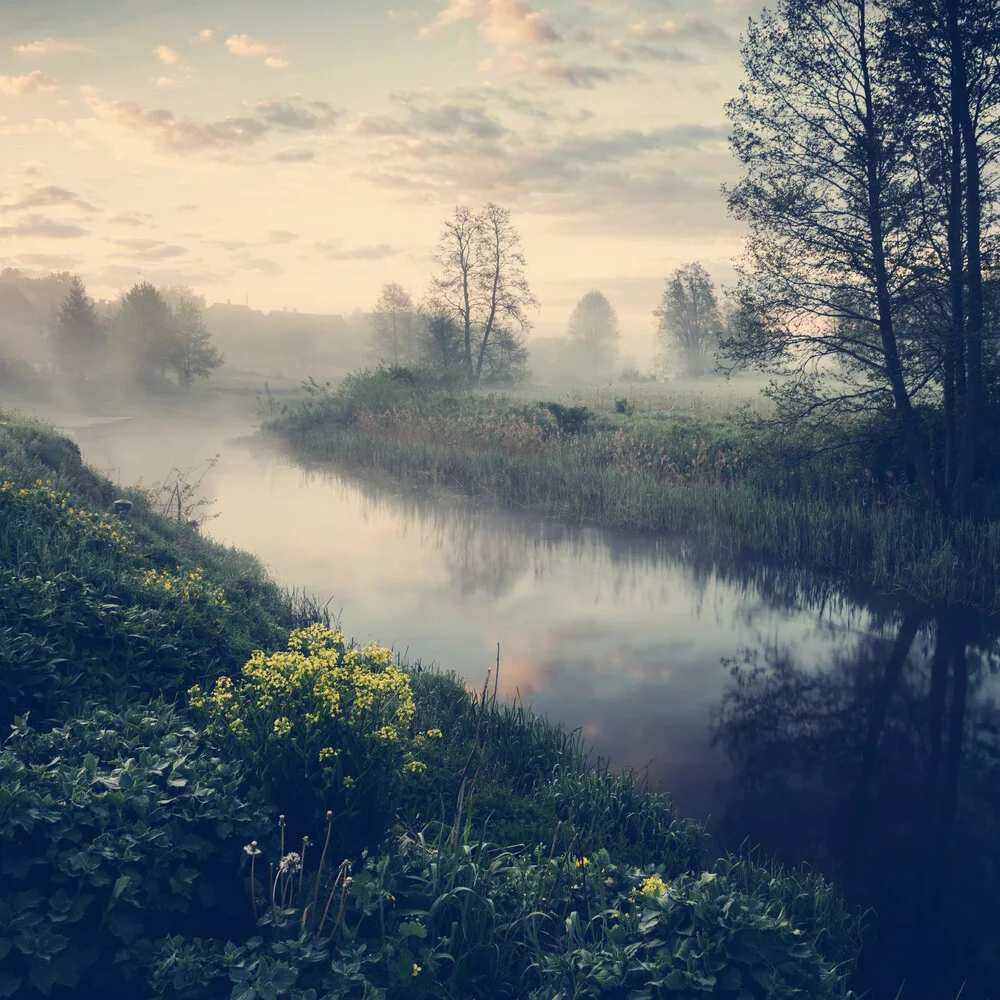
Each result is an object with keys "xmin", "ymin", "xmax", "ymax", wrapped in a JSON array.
[{"xmin": 268, "ymin": 373, "xmax": 1000, "ymax": 613}]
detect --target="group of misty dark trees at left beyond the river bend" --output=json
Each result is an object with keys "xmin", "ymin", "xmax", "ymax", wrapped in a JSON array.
[{"xmin": 52, "ymin": 276, "xmax": 223, "ymax": 389}]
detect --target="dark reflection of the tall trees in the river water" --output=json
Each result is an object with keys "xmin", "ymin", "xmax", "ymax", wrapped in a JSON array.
[{"xmin": 715, "ymin": 613, "xmax": 1000, "ymax": 1000}]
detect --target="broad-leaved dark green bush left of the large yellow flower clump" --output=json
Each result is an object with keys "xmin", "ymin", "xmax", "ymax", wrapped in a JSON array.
[{"xmin": 0, "ymin": 702, "xmax": 270, "ymax": 996}]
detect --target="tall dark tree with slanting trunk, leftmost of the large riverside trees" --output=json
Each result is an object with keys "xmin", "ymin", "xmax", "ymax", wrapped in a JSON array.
[{"xmin": 726, "ymin": 0, "xmax": 937, "ymax": 499}]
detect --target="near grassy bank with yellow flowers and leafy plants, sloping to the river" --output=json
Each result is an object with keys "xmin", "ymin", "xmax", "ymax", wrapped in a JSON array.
[{"xmin": 0, "ymin": 413, "xmax": 859, "ymax": 1000}]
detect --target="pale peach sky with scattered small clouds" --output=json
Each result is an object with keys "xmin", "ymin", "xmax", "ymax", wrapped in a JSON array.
[{"xmin": 0, "ymin": 0, "xmax": 757, "ymax": 356}]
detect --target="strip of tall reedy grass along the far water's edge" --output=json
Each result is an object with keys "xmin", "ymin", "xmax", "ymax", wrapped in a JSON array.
[{"xmin": 279, "ymin": 410, "xmax": 1000, "ymax": 614}]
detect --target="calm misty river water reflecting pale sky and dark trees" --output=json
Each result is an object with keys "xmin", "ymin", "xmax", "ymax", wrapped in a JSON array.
[{"xmin": 64, "ymin": 414, "xmax": 1000, "ymax": 1000}]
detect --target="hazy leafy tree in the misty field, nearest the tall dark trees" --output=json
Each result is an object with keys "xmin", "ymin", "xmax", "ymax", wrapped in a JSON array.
[{"xmin": 653, "ymin": 263, "xmax": 722, "ymax": 376}]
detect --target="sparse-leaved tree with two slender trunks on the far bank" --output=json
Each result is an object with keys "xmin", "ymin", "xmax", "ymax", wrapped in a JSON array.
[{"xmin": 433, "ymin": 202, "xmax": 537, "ymax": 384}]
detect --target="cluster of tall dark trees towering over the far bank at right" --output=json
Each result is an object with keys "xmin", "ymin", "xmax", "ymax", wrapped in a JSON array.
[{"xmin": 727, "ymin": 0, "xmax": 1000, "ymax": 514}]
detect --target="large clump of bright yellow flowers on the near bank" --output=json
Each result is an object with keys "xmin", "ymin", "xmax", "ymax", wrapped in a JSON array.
[{"xmin": 189, "ymin": 624, "xmax": 425, "ymax": 840}]
